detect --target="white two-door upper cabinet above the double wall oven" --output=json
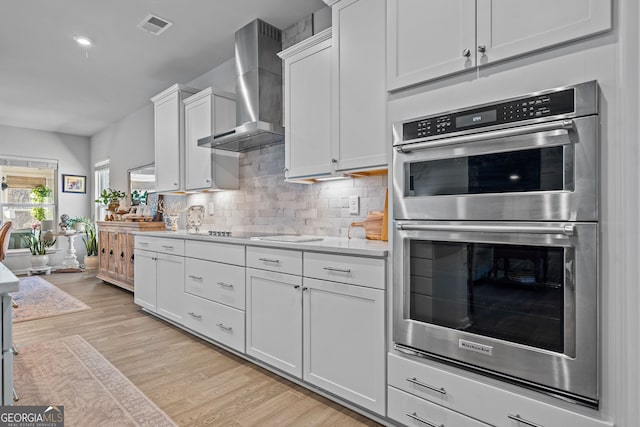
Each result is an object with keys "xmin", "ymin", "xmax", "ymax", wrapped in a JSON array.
[{"xmin": 387, "ymin": 0, "xmax": 612, "ymax": 91}]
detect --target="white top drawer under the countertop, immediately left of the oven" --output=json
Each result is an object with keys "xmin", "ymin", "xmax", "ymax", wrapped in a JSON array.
[{"xmin": 304, "ymin": 252, "xmax": 386, "ymax": 289}]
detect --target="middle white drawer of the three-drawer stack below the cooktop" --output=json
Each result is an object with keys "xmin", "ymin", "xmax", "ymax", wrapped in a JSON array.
[{"xmin": 184, "ymin": 258, "xmax": 245, "ymax": 310}]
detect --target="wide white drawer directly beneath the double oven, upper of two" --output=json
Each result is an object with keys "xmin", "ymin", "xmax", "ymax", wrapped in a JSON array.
[{"xmin": 388, "ymin": 354, "xmax": 612, "ymax": 427}]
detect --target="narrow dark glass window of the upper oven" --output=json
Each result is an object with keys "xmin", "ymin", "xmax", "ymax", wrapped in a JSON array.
[{"xmin": 408, "ymin": 147, "xmax": 565, "ymax": 196}]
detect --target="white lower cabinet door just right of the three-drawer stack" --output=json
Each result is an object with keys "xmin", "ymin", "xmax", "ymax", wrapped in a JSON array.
[{"xmin": 246, "ymin": 268, "xmax": 302, "ymax": 378}]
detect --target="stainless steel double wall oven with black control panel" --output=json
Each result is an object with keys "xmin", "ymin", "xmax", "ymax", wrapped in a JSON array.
[{"xmin": 393, "ymin": 82, "xmax": 600, "ymax": 406}]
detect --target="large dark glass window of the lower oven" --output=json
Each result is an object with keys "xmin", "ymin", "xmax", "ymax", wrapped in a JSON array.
[{"xmin": 409, "ymin": 240, "xmax": 565, "ymax": 353}]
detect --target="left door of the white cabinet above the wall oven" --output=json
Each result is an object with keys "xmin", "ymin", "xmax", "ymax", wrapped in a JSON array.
[{"xmin": 387, "ymin": 0, "xmax": 476, "ymax": 91}]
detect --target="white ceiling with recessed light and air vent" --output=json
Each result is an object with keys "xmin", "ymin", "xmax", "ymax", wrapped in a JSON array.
[{"xmin": 0, "ymin": 0, "xmax": 324, "ymax": 136}]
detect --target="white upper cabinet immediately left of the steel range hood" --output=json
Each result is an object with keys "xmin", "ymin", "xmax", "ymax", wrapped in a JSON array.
[{"xmin": 184, "ymin": 87, "xmax": 239, "ymax": 190}]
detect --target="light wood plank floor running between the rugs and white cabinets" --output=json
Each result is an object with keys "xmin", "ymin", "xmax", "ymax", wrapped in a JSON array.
[{"xmin": 13, "ymin": 273, "xmax": 378, "ymax": 427}]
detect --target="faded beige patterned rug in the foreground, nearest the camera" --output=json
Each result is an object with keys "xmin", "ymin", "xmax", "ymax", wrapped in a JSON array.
[{"xmin": 13, "ymin": 335, "xmax": 176, "ymax": 427}]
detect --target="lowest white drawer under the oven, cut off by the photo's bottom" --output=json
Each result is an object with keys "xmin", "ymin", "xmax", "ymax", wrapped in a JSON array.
[{"xmin": 387, "ymin": 387, "xmax": 489, "ymax": 427}]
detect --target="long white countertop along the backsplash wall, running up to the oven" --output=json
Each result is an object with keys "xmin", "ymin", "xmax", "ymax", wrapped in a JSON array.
[{"xmin": 133, "ymin": 230, "xmax": 389, "ymax": 258}]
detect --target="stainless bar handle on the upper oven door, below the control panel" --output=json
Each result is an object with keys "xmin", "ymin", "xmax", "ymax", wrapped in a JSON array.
[{"xmin": 395, "ymin": 120, "xmax": 574, "ymax": 153}]
